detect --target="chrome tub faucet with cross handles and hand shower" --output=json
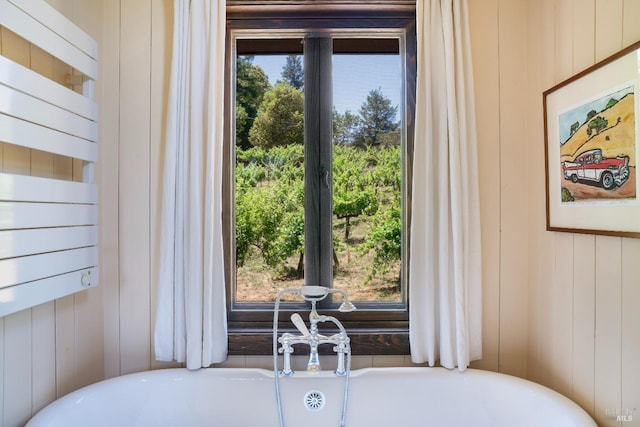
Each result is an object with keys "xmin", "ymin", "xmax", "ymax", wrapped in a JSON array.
[{"xmin": 278, "ymin": 286, "xmax": 355, "ymax": 376}]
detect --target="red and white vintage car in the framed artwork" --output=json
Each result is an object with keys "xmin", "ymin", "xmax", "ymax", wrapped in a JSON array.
[{"xmin": 562, "ymin": 149, "xmax": 629, "ymax": 190}]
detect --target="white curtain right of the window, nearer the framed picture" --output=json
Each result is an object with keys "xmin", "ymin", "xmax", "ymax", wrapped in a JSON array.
[{"xmin": 409, "ymin": 0, "xmax": 482, "ymax": 370}]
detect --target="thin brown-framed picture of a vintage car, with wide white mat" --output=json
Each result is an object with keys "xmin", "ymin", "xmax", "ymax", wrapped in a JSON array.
[{"xmin": 543, "ymin": 41, "xmax": 640, "ymax": 238}]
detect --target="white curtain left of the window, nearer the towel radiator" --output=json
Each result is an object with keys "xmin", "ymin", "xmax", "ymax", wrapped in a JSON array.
[{"xmin": 154, "ymin": 0, "xmax": 227, "ymax": 369}]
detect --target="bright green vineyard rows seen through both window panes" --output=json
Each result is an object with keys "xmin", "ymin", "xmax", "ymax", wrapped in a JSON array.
[{"xmin": 236, "ymin": 145, "xmax": 402, "ymax": 277}]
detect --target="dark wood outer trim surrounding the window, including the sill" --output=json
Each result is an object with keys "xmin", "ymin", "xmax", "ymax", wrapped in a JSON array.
[{"xmin": 223, "ymin": 0, "xmax": 416, "ymax": 355}]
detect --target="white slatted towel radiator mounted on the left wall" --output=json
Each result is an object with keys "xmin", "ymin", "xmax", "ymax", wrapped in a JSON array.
[{"xmin": 0, "ymin": 0, "xmax": 98, "ymax": 316}]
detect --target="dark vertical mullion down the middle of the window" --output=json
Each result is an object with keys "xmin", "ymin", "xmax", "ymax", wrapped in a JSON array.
[{"xmin": 304, "ymin": 36, "xmax": 333, "ymax": 292}]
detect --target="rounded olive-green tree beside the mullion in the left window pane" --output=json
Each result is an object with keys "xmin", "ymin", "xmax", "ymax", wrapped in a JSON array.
[{"xmin": 249, "ymin": 82, "xmax": 304, "ymax": 148}]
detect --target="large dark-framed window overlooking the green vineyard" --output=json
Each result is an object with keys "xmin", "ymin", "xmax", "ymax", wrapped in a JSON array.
[{"xmin": 225, "ymin": 5, "xmax": 415, "ymax": 354}]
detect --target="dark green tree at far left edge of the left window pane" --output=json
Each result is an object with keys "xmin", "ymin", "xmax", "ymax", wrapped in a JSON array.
[{"xmin": 236, "ymin": 56, "xmax": 271, "ymax": 149}]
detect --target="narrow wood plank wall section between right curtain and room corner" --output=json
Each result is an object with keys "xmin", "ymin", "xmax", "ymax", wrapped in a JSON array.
[{"xmin": 469, "ymin": 0, "xmax": 528, "ymax": 377}]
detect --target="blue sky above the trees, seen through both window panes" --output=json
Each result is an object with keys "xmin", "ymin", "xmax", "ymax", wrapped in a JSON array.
[{"xmin": 253, "ymin": 55, "xmax": 402, "ymax": 119}]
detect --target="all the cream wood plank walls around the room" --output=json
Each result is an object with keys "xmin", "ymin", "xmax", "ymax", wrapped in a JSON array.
[{"xmin": 0, "ymin": 0, "xmax": 640, "ymax": 427}]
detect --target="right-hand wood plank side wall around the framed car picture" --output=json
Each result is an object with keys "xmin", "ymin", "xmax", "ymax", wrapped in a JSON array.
[{"xmin": 524, "ymin": 0, "xmax": 640, "ymax": 426}]
